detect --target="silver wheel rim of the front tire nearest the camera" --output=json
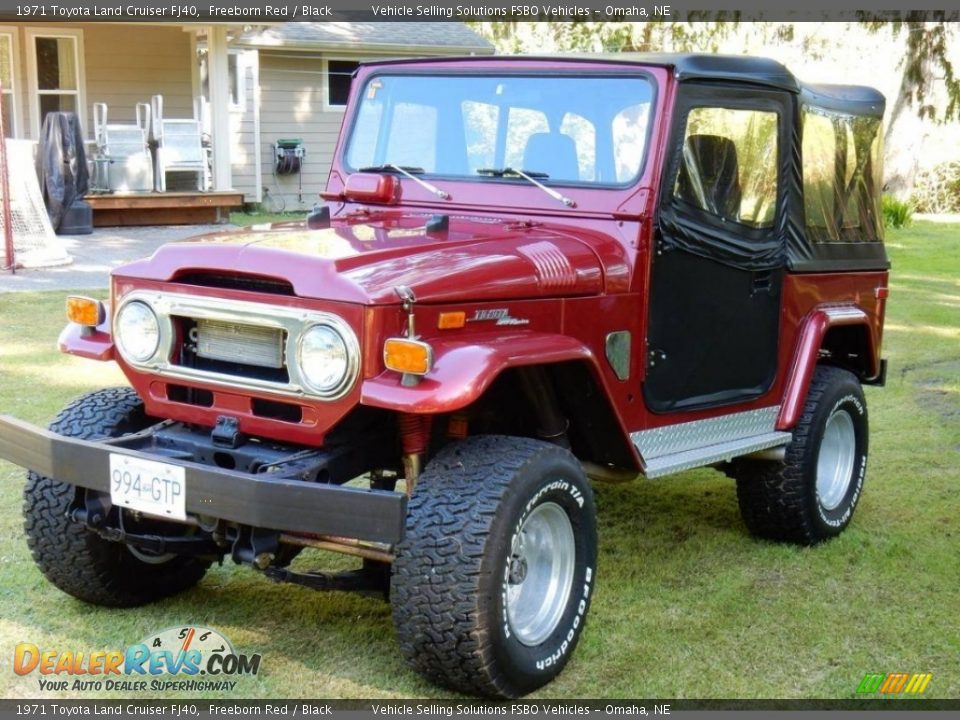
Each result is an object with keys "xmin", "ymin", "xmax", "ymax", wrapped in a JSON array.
[{"xmin": 506, "ymin": 502, "xmax": 577, "ymax": 646}]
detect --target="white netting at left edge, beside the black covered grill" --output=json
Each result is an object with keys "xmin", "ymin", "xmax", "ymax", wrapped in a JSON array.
[{"xmin": 0, "ymin": 140, "xmax": 71, "ymax": 268}]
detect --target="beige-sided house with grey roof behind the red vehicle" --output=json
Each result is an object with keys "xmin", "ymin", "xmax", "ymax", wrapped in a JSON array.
[{"xmin": 0, "ymin": 22, "xmax": 493, "ymax": 224}]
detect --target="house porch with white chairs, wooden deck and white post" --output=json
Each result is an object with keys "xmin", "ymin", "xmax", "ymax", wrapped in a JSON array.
[{"xmin": 0, "ymin": 23, "xmax": 248, "ymax": 222}]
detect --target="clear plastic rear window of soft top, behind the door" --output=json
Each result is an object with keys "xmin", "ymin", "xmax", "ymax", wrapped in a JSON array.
[{"xmin": 801, "ymin": 106, "xmax": 883, "ymax": 243}]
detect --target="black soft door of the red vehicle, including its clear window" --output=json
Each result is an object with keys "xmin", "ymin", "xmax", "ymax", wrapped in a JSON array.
[{"xmin": 644, "ymin": 83, "xmax": 791, "ymax": 412}]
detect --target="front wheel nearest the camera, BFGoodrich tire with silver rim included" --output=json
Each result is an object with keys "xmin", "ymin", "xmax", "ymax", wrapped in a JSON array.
[{"xmin": 390, "ymin": 435, "xmax": 597, "ymax": 697}]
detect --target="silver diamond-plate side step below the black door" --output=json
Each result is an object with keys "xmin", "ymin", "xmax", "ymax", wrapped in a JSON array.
[{"xmin": 630, "ymin": 405, "xmax": 780, "ymax": 464}]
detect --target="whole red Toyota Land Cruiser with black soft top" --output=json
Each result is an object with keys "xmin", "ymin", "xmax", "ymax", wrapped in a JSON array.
[{"xmin": 0, "ymin": 56, "xmax": 888, "ymax": 696}]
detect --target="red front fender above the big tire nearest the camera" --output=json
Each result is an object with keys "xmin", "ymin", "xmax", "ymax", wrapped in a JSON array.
[{"xmin": 360, "ymin": 332, "xmax": 596, "ymax": 413}]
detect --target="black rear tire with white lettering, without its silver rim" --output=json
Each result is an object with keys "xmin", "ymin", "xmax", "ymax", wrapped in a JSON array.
[{"xmin": 734, "ymin": 365, "xmax": 869, "ymax": 545}]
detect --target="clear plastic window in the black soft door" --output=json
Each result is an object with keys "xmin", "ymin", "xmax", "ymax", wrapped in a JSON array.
[{"xmin": 673, "ymin": 107, "xmax": 778, "ymax": 228}]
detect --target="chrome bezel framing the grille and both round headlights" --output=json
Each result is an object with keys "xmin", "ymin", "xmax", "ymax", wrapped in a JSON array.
[{"xmin": 113, "ymin": 290, "xmax": 360, "ymax": 400}]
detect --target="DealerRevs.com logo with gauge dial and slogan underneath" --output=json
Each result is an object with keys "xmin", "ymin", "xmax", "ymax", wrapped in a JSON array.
[{"xmin": 13, "ymin": 625, "xmax": 260, "ymax": 692}]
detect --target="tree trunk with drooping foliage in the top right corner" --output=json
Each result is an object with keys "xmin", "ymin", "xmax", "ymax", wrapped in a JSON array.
[{"xmin": 864, "ymin": 16, "xmax": 960, "ymax": 200}]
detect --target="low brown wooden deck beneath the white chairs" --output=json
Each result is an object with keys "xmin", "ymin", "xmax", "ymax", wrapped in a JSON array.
[{"xmin": 84, "ymin": 190, "xmax": 243, "ymax": 227}]
